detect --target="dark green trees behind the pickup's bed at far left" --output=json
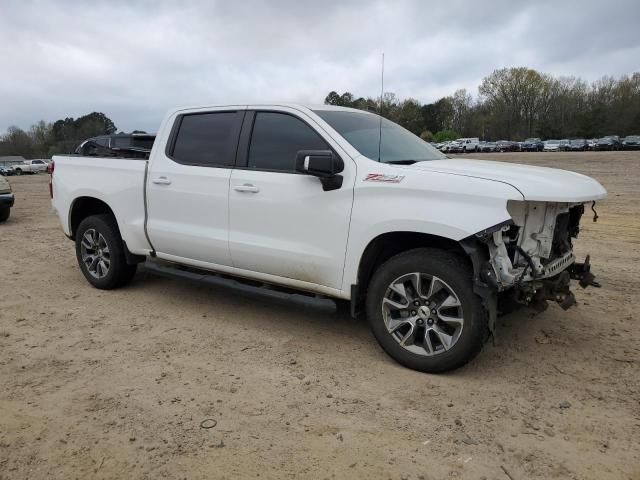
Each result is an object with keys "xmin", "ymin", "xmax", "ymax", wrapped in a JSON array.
[{"xmin": 0, "ymin": 112, "xmax": 117, "ymax": 158}]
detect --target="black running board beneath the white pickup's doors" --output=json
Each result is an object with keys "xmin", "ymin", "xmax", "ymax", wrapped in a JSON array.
[{"xmin": 141, "ymin": 259, "xmax": 335, "ymax": 308}]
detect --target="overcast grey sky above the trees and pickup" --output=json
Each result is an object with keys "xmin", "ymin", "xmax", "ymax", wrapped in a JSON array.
[{"xmin": 0, "ymin": 0, "xmax": 640, "ymax": 132}]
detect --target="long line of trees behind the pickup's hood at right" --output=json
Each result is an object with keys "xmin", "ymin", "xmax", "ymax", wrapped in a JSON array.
[{"xmin": 325, "ymin": 67, "xmax": 640, "ymax": 141}]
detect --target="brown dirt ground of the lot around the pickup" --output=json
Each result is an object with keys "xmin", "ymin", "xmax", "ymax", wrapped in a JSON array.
[{"xmin": 0, "ymin": 152, "xmax": 640, "ymax": 480}]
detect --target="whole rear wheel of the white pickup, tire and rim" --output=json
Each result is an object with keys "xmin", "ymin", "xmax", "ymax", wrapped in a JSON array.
[{"xmin": 76, "ymin": 214, "xmax": 137, "ymax": 290}]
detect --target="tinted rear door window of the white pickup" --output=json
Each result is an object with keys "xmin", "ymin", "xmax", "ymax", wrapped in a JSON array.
[{"xmin": 169, "ymin": 112, "xmax": 244, "ymax": 167}]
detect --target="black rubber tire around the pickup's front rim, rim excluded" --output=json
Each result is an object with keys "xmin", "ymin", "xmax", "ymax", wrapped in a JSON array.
[{"xmin": 366, "ymin": 248, "xmax": 489, "ymax": 373}]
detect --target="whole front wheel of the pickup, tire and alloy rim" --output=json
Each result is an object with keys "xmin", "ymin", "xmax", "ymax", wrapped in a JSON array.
[{"xmin": 366, "ymin": 248, "xmax": 488, "ymax": 373}]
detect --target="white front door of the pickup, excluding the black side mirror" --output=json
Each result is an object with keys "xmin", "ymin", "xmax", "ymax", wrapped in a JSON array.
[{"xmin": 229, "ymin": 107, "xmax": 355, "ymax": 289}]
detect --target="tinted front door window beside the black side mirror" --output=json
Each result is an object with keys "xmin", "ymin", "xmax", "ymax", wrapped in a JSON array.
[{"xmin": 248, "ymin": 112, "xmax": 331, "ymax": 172}]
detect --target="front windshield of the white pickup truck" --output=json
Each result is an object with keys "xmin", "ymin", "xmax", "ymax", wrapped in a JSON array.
[{"xmin": 314, "ymin": 110, "xmax": 447, "ymax": 163}]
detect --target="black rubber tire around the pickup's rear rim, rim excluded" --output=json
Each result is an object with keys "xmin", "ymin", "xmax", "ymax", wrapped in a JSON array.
[{"xmin": 76, "ymin": 214, "xmax": 137, "ymax": 290}]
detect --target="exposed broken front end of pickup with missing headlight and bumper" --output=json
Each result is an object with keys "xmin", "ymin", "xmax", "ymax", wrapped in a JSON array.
[{"xmin": 476, "ymin": 201, "xmax": 598, "ymax": 309}]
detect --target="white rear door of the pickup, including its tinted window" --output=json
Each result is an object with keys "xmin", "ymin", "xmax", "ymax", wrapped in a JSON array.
[{"xmin": 147, "ymin": 109, "xmax": 245, "ymax": 266}]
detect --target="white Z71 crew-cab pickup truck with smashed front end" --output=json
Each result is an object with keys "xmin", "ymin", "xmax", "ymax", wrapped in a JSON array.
[{"xmin": 51, "ymin": 104, "xmax": 606, "ymax": 372}]
